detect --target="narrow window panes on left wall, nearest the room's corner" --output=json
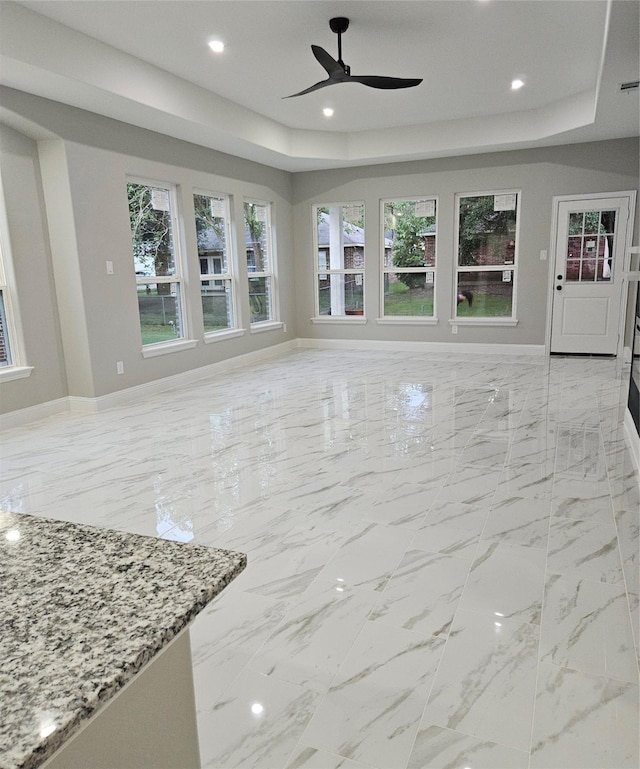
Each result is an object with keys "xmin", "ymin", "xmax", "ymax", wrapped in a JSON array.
[{"xmin": 244, "ymin": 201, "xmax": 276, "ymax": 323}]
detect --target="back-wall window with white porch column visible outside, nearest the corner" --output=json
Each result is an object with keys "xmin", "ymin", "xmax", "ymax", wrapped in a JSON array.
[{"xmin": 314, "ymin": 203, "xmax": 364, "ymax": 316}]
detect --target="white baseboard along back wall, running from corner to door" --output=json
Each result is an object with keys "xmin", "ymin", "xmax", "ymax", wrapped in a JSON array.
[{"xmin": 295, "ymin": 338, "xmax": 545, "ymax": 356}]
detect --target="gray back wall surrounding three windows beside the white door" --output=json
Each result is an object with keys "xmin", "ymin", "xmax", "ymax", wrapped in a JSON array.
[{"xmin": 294, "ymin": 139, "xmax": 638, "ymax": 345}]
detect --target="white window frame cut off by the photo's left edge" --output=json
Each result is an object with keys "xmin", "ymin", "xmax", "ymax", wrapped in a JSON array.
[{"xmin": 0, "ymin": 178, "xmax": 34, "ymax": 382}]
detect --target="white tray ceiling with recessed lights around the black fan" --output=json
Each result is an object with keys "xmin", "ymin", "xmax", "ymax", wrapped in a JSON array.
[{"xmin": 0, "ymin": 0, "xmax": 639, "ymax": 171}]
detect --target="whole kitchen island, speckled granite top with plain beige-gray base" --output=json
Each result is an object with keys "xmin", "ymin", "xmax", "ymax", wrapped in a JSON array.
[{"xmin": 0, "ymin": 511, "xmax": 246, "ymax": 769}]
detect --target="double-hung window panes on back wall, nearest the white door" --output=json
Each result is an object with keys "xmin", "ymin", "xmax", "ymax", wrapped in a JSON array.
[{"xmin": 456, "ymin": 192, "xmax": 520, "ymax": 318}]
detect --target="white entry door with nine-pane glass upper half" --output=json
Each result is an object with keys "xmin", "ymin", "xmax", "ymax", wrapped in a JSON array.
[{"xmin": 551, "ymin": 194, "xmax": 632, "ymax": 355}]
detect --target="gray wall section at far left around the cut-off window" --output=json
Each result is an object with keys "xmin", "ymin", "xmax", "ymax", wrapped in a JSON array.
[{"xmin": 0, "ymin": 125, "xmax": 67, "ymax": 412}]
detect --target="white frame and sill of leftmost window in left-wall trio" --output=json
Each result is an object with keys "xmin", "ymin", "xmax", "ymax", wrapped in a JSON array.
[{"xmin": 125, "ymin": 174, "xmax": 192, "ymax": 358}]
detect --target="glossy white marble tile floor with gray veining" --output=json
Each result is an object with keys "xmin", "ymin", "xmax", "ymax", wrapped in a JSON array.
[{"xmin": 0, "ymin": 350, "xmax": 640, "ymax": 769}]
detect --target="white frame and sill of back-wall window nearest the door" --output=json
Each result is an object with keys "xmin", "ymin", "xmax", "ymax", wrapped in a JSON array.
[{"xmin": 449, "ymin": 188, "xmax": 522, "ymax": 326}]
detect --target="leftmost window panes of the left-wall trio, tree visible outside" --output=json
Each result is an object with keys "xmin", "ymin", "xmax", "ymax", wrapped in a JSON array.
[{"xmin": 127, "ymin": 182, "xmax": 185, "ymax": 345}]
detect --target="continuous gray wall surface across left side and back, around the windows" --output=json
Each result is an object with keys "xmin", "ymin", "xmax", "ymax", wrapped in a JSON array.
[{"xmin": 0, "ymin": 89, "xmax": 638, "ymax": 412}]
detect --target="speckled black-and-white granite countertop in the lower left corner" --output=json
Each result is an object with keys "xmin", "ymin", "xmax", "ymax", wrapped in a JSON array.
[{"xmin": 0, "ymin": 511, "xmax": 246, "ymax": 769}]
